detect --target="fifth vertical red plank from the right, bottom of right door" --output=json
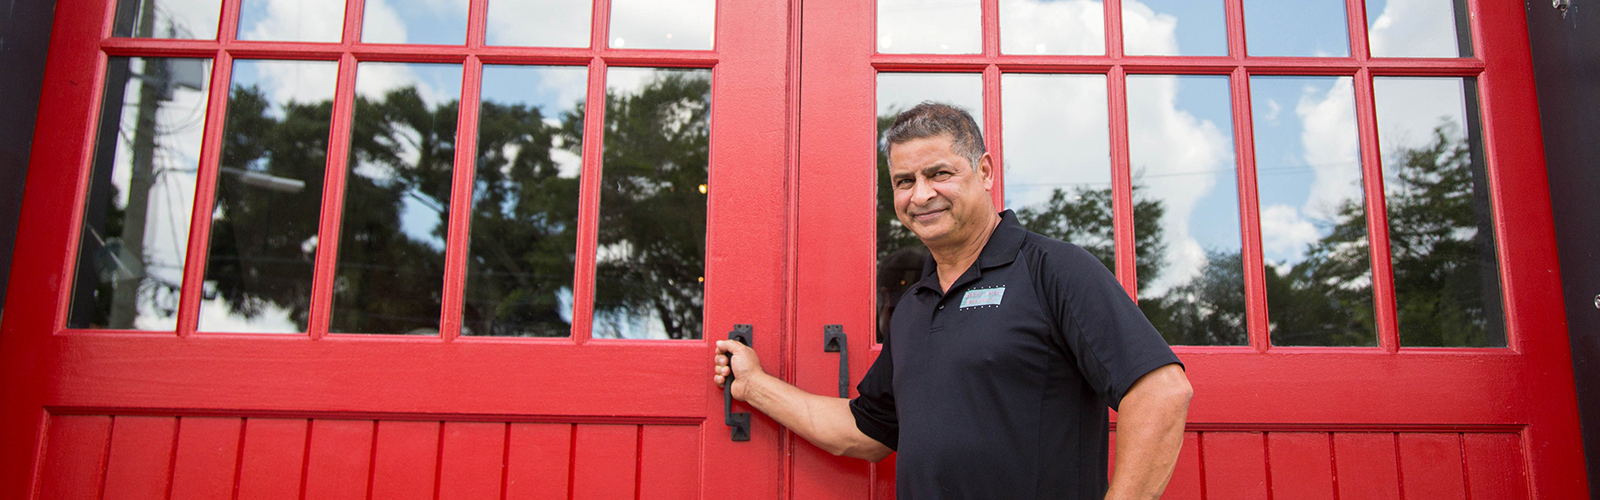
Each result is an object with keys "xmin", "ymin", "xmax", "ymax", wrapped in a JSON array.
[{"xmin": 1205, "ymin": 433, "xmax": 1267, "ymax": 500}]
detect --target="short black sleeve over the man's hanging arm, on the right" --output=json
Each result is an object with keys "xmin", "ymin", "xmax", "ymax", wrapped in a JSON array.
[{"xmin": 1040, "ymin": 244, "xmax": 1182, "ymax": 410}]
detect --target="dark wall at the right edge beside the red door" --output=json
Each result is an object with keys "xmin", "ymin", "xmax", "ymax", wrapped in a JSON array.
[{"xmin": 1526, "ymin": 0, "xmax": 1600, "ymax": 498}]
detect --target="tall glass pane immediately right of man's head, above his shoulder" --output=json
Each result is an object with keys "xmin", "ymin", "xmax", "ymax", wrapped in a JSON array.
[{"xmin": 1000, "ymin": 74, "xmax": 1113, "ymax": 272}]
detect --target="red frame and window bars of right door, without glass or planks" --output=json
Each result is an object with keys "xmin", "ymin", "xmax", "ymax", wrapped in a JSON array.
[{"xmin": 794, "ymin": 0, "xmax": 1587, "ymax": 498}]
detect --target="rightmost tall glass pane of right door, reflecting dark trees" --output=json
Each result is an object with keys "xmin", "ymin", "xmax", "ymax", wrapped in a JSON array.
[{"xmin": 1373, "ymin": 79, "xmax": 1506, "ymax": 348}]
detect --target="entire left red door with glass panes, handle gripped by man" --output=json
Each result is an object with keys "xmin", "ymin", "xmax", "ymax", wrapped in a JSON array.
[{"xmin": 0, "ymin": 0, "xmax": 794, "ymax": 498}]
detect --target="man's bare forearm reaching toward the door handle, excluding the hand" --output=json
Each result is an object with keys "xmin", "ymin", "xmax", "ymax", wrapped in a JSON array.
[{"xmin": 732, "ymin": 373, "xmax": 891, "ymax": 462}]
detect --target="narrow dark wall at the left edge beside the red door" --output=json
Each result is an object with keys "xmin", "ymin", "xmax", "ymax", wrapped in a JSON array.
[{"xmin": 0, "ymin": 0, "xmax": 56, "ymax": 310}]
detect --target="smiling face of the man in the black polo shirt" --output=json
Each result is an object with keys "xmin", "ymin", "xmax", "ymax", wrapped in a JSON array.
[{"xmin": 890, "ymin": 135, "xmax": 995, "ymax": 247}]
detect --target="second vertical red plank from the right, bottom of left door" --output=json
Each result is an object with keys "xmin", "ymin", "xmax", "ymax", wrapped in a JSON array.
[{"xmin": 573, "ymin": 425, "xmax": 638, "ymax": 500}]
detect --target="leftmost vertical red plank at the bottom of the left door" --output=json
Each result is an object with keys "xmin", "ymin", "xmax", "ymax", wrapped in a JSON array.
[{"xmin": 38, "ymin": 415, "xmax": 110, "ymax": 500}]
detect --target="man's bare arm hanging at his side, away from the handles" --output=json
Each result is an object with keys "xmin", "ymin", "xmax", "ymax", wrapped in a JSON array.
[{"xmin": 1106, "ymin": 364, "xmax": 1194, "ymax": 500}]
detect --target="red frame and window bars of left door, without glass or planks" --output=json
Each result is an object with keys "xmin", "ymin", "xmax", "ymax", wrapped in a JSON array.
[{"xmin": 0, "ymin": 0, "xmax": 798, "ymax": 498}]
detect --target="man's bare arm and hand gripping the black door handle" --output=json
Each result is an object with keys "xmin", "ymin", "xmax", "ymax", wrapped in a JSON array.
[{"xmin": 712, "ymin": 340, "xmax": 896, "ymax": 462}]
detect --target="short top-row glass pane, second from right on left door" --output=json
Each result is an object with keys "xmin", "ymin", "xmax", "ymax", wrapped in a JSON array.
[{"xmin": 486, "ymin": 0, "xmax": 595, "ymax": 46}]
